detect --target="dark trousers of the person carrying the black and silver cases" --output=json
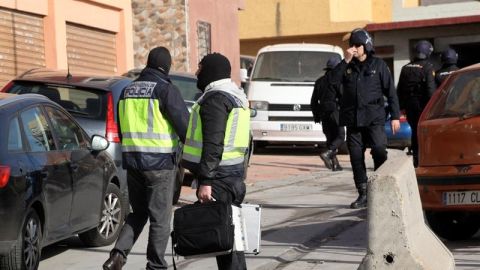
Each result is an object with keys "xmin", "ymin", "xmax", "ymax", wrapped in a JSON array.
[{"xmin": 202, "ymin": 177, "xmax": 247, "ymax": 270}]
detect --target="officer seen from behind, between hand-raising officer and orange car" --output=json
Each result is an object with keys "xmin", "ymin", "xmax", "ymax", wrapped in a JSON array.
[{"xmin": 397, "ymin": 40, "xmax": 436, "ymax": 167}]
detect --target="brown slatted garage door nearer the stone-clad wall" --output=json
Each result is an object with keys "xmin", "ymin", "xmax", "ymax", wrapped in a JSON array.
[{"xmin": 67, "ymin": 24, "xmax": 117, "ymax": 74}]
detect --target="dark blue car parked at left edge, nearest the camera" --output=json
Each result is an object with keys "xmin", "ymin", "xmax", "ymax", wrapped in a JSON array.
[{"xmin": 0, "ymin": 93, "xmax": 127, "ymax": 270}]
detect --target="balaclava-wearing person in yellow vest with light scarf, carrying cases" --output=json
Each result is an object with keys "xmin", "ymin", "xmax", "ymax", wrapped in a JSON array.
[{"xmin": 183, "ymin": 53, "xmax": 250, "ymax": 270}]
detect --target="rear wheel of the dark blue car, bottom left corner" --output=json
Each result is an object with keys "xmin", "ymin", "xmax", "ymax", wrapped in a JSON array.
[{"xmin": 0, "ymin": 209, "xmax": 42, "ymax": 270}]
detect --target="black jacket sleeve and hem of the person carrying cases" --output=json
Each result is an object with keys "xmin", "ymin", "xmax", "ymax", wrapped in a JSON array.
[{"xmin": 192, "ymin": 91, "xmax": 244, "ymax": 185}]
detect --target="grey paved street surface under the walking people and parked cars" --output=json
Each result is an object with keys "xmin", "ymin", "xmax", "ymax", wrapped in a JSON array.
[{"xmin": 40, "ymin": 149, "xmax": 480, "ymax": 270}]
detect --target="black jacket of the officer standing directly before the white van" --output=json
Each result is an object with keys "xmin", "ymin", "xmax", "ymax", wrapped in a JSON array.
[{"xmin": 310, "ymin": 71, "xmax": 342, "ymax": 123}]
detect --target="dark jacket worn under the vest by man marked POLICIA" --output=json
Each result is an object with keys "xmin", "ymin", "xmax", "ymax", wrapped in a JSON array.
[{"xmin": 117, "ymin": 67, "xmax": 189, "ymax": 171}]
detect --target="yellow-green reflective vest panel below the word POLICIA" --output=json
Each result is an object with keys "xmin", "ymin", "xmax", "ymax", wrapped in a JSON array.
[{"xmin": 118, "ymin": 98, "xmax": 178, "ymax": 153}]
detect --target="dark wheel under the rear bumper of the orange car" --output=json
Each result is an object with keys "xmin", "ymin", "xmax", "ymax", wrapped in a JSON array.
[{"xmin": 425, "ymin": 211, "xmax": 480, "ymax": 241}]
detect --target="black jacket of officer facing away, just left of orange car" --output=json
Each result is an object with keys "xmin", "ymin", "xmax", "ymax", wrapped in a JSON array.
[{"xmin": 397, "ymin": 59, "xmax": 436, "ymax": 109}]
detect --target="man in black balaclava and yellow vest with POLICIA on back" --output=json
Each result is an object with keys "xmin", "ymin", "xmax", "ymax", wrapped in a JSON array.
[{"xmin": 103, "ymin": 47, "xmax": 189, "ymax": 270}]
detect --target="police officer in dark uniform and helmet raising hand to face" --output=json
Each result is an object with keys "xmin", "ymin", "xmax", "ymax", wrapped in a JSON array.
[{"xmin": 328, "ymin": 28, "xmax": 400, "ymax": 208}]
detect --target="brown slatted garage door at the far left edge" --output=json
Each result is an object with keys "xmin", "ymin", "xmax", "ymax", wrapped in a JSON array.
[{"xmin": 0, "ymin": 9, "xmax": 45, "ymax": 86}]
